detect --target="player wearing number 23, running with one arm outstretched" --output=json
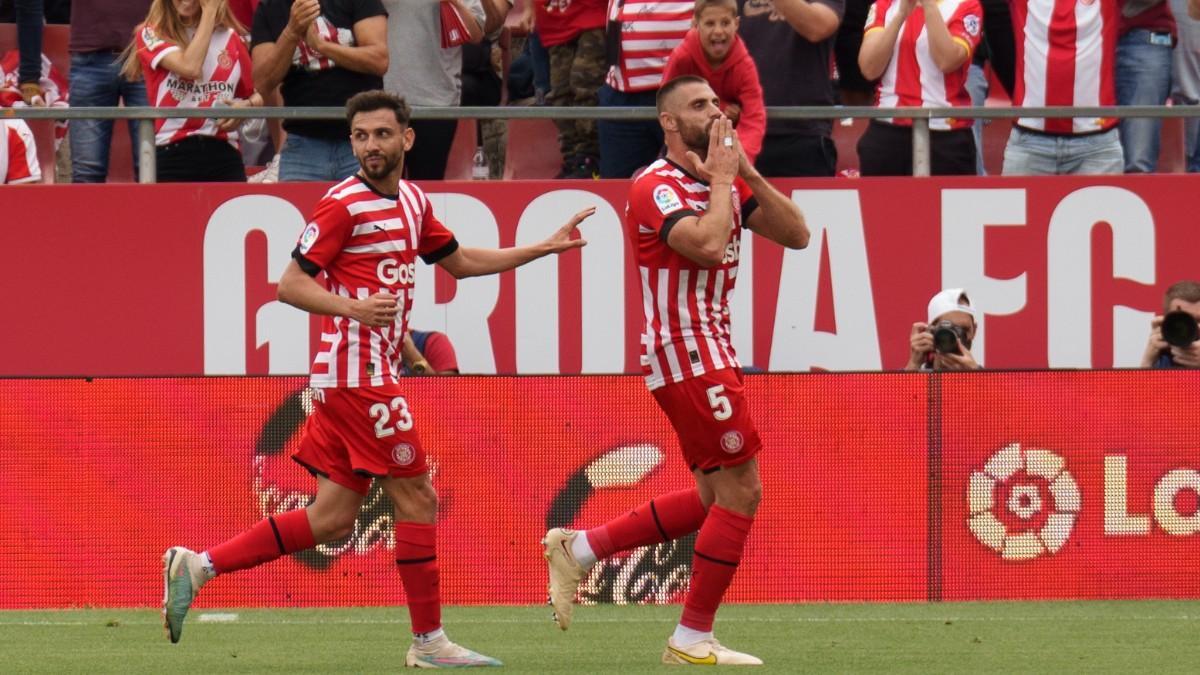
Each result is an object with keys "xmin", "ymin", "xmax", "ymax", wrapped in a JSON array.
[{"xmin": 162, "ymin": 90, "xmax": 594, "ymax": 668}]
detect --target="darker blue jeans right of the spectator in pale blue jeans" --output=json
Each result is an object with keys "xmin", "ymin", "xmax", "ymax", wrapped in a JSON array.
[{"xmin": 1116, "ymin": 29, "xmax": 1174, "ymax": 173}]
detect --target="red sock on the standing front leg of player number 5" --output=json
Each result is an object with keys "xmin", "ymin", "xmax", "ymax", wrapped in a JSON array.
[{"xmin": 679, "ymin": 504, "xmax": 754, "ymax": 633}]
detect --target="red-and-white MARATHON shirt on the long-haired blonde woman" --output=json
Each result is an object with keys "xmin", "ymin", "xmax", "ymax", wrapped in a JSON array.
[{"xmin": 137, "ymin": 25, "xmax": 254, "ymax": 148}]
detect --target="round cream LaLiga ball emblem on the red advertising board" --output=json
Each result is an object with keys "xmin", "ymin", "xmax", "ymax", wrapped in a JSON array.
[{"xmin": 967, "ymin": 443, "xmax": 1081, "ymax": 560}]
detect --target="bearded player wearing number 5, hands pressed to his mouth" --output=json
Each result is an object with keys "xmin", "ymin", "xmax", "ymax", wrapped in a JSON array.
[{"xmin": 542, "ymin": 76, "xmax": 809, "ymax": 665}]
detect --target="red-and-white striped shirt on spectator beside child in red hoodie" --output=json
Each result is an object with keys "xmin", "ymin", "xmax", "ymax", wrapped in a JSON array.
[{"xmin": 607, "ymin": 0, "xmax": 696, "ymax": 94}]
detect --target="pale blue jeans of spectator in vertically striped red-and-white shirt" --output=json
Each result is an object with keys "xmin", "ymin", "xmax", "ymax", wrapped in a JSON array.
[{"xmin": 1003, "ymin": 126, "xmax": 1124, "ymax": 175}]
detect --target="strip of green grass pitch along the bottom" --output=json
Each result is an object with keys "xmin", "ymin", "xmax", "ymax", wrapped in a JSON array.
[{"xmin": 0, "ymin": 601, "xmax": 1200, "ymax": 675}]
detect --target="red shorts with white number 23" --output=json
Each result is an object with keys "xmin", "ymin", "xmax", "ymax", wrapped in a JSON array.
[{"xmin": 292, "ymin": 386, "xmax": 428, "ymax": 495}]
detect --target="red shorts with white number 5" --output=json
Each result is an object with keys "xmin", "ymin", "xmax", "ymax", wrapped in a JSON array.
[{"xmin": 652, "ymin": 368, "xmax": 762, "ymax": 472}]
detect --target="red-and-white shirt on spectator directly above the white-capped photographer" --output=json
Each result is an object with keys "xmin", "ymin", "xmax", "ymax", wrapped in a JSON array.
[{"xmin": 865, "ymin": 0, "xmax": 983, "ymax": 131}]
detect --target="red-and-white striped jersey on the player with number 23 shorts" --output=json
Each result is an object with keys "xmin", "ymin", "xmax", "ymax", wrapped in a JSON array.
[{"xmin": 292, "ymin": 175, "xmax": 458, "ymax": 388}]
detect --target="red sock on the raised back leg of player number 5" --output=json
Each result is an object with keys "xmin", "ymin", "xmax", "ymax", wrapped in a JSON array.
[{"xmin": 587, "ymin": 488, "xmax": 704, "ymax": 560}]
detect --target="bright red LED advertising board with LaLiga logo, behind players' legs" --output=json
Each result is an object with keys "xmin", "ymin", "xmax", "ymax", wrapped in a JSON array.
[{"xmin": 0, "ymin": 371, "xmax": 1200, "ymax": 609}]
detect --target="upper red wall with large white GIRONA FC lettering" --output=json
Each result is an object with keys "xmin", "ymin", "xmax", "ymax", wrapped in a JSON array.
[{"xmin": 0, "ymin": 175, "xmax": 1200, "ymax": 376}]
